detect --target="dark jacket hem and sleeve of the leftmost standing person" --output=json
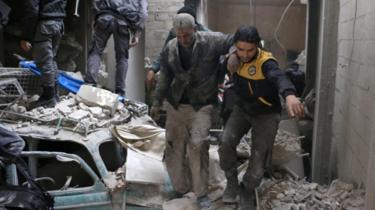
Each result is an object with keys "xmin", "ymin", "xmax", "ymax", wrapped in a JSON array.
[{"xmin": 22, "ymin": 0, "xmax": 67, "ymax": 40}]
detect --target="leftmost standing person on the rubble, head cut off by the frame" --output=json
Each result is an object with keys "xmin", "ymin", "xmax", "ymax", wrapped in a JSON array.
[{"xmin": 21, "ymin": 0, "xmax": 67, "ymax": 109}]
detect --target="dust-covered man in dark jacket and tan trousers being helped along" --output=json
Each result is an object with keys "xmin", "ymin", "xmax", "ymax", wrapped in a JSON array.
[{"xmin": 151, "ymin": 13, "xmax": 233, "ymax": 209}]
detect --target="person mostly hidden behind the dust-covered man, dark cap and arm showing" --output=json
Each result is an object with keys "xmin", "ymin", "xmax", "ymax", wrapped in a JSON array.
[{"xmin": 146, "ymin": 6, "xmax": 209, "ymax": 90}]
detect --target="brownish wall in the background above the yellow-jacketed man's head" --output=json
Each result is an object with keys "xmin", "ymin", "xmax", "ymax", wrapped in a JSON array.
[{"xmin": 203, "ymin": 0, "xmax": 306, "ymax": 66}]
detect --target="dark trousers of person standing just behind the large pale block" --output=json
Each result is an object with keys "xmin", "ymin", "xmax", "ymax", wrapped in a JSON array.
[{"xmin": 85, "ymin": 15, "xmax": 129, "ymax": 95}]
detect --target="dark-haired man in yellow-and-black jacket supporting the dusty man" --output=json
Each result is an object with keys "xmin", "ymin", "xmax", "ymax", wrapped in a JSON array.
[{"xmin": 219, "ymin": 26, "xmax": 304, "ymax": 210}]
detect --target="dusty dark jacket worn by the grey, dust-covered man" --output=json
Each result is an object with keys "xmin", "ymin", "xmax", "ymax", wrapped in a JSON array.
[{"xmin": 154, "ymin": 31, "xmax": 232, "ymax": 110}]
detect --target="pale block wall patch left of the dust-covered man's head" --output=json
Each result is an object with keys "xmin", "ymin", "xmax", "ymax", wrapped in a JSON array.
[{"xmin": 145, "ymin": 0, "xmax": 184, "ymax": 60}]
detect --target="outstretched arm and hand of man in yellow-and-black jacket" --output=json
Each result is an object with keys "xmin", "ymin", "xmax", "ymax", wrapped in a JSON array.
[{"xmin": 262, "ymin": 60, "xmax": 304, "ymax": 118}]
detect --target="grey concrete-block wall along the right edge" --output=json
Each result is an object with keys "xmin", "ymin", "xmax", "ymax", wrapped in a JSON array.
[{"xmin": 330, "ymin": 0, "xmax": 375, "ymax": 209}]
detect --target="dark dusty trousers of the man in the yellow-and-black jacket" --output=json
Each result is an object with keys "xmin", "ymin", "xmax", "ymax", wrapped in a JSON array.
[{"xmin": 219, "ymin": 105, "xmax": 280, "ymax": 192}]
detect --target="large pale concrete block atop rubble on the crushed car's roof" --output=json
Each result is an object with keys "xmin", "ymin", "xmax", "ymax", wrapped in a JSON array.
[{"xmin": 77, "ymin": 85, "xmax": 119, "ymax": 114}]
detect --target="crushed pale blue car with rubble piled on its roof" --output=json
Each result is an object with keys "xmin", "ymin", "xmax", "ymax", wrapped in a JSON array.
[{"xmin": 0, "ymin": 68, "xmax": 161, "ymax": 210}]
